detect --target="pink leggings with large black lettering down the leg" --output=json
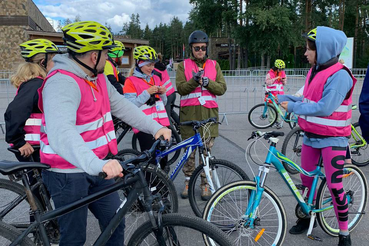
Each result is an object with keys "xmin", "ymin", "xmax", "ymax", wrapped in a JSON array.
[{"xmin": 300, "ymin": 145, "xmax": 348, "ymax": 230}]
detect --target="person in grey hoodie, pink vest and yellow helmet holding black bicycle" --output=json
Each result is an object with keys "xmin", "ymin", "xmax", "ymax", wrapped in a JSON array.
[{"xmin": 39, "ymin": 21, "xmax": 171, "ymax": 245}]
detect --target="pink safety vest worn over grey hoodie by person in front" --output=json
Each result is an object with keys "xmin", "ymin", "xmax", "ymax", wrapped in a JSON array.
[{"xmin": 38, "ymin": 70, "xmax": 118, "ymax": 169}]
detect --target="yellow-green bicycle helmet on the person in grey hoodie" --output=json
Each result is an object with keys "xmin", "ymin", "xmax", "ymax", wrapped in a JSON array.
[{"xmin": 62, "ymin": 21, "xmax": 116, "ymax": 53}]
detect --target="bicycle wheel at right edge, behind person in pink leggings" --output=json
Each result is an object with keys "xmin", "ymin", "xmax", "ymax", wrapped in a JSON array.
[{"xmin": 349, "ymin": 122, "xmax": 369, "ymax": 167}]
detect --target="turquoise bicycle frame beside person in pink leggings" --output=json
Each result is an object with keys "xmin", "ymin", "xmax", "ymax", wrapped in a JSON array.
[{"xmin": 244, "ymin": 138, "xmax": 351, "ymax": 229}]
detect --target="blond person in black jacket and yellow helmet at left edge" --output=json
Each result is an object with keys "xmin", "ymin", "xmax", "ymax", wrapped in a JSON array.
[{"xmin": 4, "ymin": 39, "xmax": 58, "ymax": 161}]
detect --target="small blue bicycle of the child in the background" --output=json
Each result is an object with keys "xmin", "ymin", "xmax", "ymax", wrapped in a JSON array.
[{"xmin": 248, "ymin": 89, "xmax": 297, "ymax": 129}]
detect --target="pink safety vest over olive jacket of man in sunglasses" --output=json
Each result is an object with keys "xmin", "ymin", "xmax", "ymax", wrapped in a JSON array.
[{"xmin": 181, "ymin": 59, "xmax": 218, "ymax": 108}]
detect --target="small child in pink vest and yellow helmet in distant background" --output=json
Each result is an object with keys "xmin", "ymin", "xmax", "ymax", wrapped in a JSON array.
[{"xmin": 265, "ymin": 59, "xmax": 287, "ymax": 129}]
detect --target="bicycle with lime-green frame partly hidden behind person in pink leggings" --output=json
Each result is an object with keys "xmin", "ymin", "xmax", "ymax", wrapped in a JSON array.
[{"xmin": 281, "ymin": 122, "xmax": 369, "ymax": 174}]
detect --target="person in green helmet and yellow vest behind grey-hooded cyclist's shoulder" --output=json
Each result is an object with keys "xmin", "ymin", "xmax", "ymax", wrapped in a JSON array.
[{"xmin": 104, "ymin": 40, "xmax": 126, "ymax": 94}]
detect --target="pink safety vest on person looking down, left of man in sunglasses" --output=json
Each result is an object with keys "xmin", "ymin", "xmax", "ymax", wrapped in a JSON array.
[{"xmin": 128, "ymin": 75, "xmax": 170, "ymax": 133}]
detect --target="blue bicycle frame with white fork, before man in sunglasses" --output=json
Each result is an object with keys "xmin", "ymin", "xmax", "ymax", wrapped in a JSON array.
[{"xmin": 156, "ymin": 132, "xmax": 220, "ymax": 193}]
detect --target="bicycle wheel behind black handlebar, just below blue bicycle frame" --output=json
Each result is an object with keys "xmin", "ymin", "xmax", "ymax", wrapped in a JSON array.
[{"xmin": 119, "ymin": 164, "xmax": 178, "ymax": 244}]
